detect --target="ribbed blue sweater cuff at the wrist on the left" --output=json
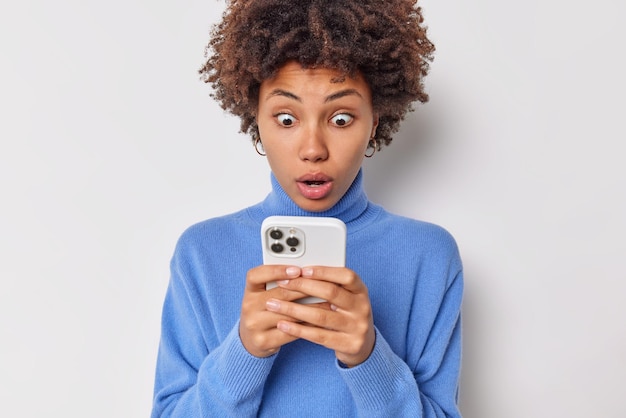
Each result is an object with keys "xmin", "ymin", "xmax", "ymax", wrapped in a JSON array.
[{"xmin": 212, "ymin": 322, "xmax": 276, "ymax": 399}]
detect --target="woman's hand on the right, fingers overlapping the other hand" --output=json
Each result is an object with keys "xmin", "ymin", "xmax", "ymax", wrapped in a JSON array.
[{"xmin": 265, "ymin": 267, "xmax": 375, "ymax": 367}]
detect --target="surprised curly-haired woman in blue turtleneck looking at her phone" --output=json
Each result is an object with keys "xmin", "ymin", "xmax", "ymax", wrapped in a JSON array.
[{"xmin": 152, "ymin": 0, "xmax": 463, "ymax": 418}]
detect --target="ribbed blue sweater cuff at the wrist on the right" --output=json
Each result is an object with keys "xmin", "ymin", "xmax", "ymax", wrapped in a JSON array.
[{"xmin": 337, "ymin": 329, "xmax": 415, "ymax": 411}]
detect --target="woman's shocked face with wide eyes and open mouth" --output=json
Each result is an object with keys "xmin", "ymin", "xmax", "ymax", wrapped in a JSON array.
[{"xmin": 257, "ymin": 62, "xmax": 378, "ymax": 212}]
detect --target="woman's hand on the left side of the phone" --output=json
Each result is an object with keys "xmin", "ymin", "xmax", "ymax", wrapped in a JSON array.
[{"xmin": 239, "ymin": 265, "xmax": 306, "ymax": 357}]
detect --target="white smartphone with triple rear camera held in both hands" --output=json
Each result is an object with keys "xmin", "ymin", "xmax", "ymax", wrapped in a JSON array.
[{"xmin": 261, "ymin": 216, "xmax": 346, "ymax": 303}]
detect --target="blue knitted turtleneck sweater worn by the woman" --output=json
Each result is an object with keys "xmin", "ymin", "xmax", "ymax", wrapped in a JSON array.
[{"xmin": 152, "ymin": 172, "xmax": 463, "ymax": 418}]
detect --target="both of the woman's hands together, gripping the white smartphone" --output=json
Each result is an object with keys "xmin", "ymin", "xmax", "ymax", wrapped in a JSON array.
[{"xmin": 239, "ymin": 265, "xmax": 375, "ymax": 367}]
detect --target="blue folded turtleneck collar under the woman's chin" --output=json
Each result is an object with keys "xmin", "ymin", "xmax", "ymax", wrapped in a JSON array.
[{"xmin": 251, "ymin": 169, "xmax": 380, "ymax": 229}]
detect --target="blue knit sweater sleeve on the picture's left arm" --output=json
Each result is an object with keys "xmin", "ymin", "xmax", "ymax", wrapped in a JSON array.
[{"xmin": 152, "ymin": 225, "xmax": 274, "ymax": 418}]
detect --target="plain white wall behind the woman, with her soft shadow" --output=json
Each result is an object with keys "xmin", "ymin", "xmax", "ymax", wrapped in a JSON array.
[{"xmin": 0, "ymin": 0, "xmax": 626, "ymax": 418}]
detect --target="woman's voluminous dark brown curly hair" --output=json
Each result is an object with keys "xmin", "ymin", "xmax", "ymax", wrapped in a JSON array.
[{"xmin": 199, "ymin": 0, "xmax": 435, "ymax": 149}]
